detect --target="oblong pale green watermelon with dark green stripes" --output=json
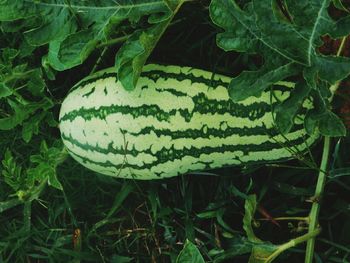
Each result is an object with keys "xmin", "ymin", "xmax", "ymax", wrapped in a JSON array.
[{"xmin": 59, "ymin": 64, "xmax": 319, "ymax": 180}]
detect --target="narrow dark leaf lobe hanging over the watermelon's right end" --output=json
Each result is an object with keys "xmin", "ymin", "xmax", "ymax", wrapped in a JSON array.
[{"xmin": 275, "ymin": 82, "xmax": 311, "ymax": 134}]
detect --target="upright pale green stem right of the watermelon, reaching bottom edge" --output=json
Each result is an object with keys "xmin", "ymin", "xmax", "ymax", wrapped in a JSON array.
[{"xmin": 305, "ymin": 136, "xmax": 330, "ymax": 263}]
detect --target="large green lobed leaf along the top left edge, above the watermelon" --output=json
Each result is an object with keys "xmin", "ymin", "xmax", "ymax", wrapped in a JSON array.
[{"xmin": 0, "ymin": 0, "xmax": 172, "ymax": 70}]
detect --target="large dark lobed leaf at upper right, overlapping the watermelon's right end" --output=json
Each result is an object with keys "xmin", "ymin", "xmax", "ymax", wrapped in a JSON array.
[{"xmin": 210, "ymin": 0, "xmax": 350, "ymax": 136}]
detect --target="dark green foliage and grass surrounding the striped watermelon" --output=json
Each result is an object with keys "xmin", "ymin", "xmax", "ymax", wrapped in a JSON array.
[{"xmin": 0, "ymin": 0, "xmax": 350, "ymax": 263}]
